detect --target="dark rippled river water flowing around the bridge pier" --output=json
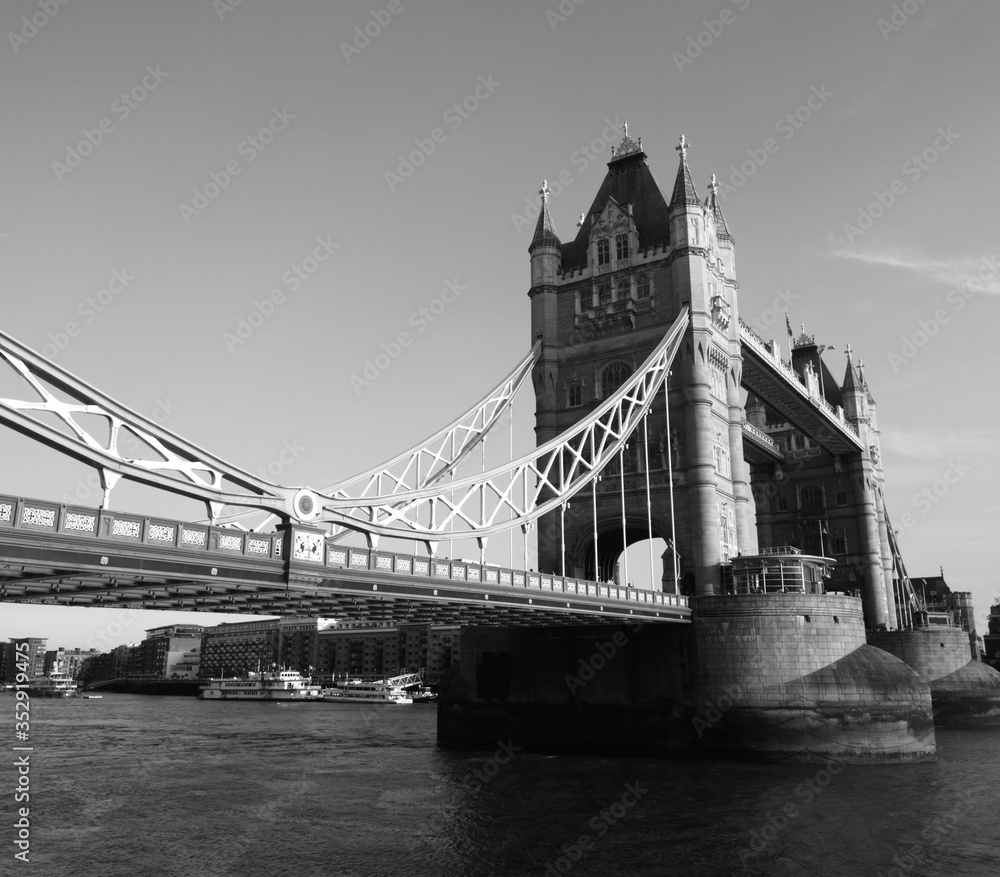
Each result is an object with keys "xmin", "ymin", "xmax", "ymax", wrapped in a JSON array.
[{"xmin": 9, "ymin": 694, "xmax": 1000, "ymax": 877}]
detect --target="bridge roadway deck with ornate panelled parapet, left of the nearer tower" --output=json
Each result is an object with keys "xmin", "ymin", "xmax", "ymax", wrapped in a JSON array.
[{"xmin": 0, "ymin": 495, "xmax": 691, "ymax": 626}]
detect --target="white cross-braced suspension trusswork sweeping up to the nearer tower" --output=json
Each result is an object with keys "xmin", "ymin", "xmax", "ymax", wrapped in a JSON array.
[{"xmin": 0, "ymin": 309, "xmax": 688, "ymax": 544}]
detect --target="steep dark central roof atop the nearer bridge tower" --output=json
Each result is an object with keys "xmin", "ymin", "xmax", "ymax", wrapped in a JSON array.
[{"xmin": 560, "ymin": 123, "xmax": 670, "ymax": 269}]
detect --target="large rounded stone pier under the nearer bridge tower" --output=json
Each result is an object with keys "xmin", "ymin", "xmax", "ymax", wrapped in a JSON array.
[{"xmin": 438, "ymin": 594, "xmax": 935, "ymax": 763}]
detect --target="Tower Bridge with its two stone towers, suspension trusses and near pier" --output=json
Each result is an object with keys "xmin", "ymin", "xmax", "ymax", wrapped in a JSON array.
[{"xmin": 0, "ymin": 128, "xmax": 1000, "ymax": 761}]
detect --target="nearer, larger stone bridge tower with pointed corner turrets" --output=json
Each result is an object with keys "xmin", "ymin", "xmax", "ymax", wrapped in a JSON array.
[{"xmin": 528, "ymin": 125, "xmax": 757, "ymax": 594}]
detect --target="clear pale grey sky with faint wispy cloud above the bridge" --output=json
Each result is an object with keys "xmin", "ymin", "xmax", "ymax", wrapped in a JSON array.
[{"xmin": 0, "ymin": 0, "xmax": 1000, "ymax": 646}]
